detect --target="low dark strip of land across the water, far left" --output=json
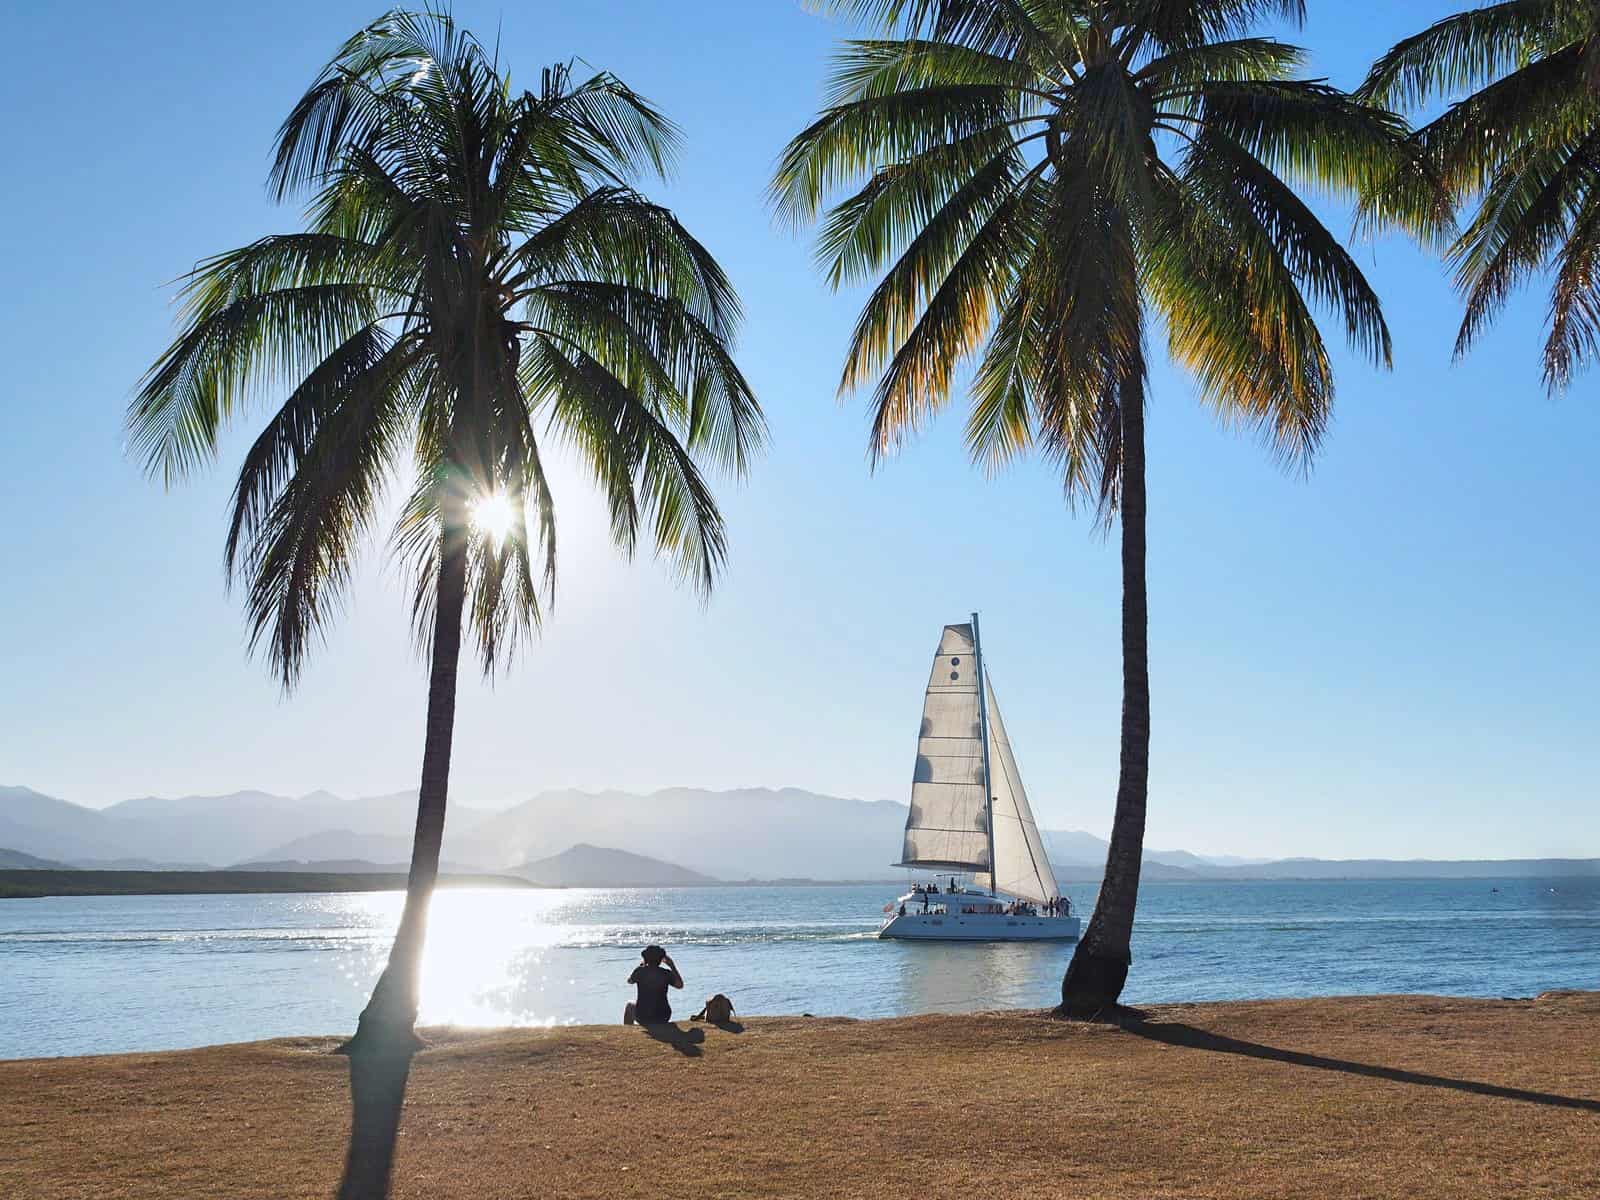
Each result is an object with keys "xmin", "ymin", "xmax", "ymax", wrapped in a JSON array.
[{"xmin": 0, "ymin": 870, "xmax": 534, "ymax": 899}]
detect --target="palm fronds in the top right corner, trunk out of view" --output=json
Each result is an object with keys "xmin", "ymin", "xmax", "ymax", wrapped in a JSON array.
[{"xmin": 1358, "ymin": 0, "xmax": 1600, "ymax": 392}]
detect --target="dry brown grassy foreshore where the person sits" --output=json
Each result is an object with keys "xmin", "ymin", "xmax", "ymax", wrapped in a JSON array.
[{"xmin": 0, "ymin": 992, "xmax": 1600, "ymax": 1200}]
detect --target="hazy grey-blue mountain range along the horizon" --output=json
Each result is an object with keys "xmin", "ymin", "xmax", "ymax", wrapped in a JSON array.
[{"xmin": 0, "ymin": 787, "xmax": 1600, "ymax": 883}]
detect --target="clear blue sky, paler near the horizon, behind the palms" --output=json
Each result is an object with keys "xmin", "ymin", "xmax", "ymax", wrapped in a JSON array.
[{"xmin": 0, "ymin": 0, "xmax": 1600, "ymax": 858}]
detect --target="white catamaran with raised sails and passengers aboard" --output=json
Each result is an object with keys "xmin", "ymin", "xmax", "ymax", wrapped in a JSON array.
[{"xmin": 878, "ymin": 613, "xmax": 1078, "ymax": 942}]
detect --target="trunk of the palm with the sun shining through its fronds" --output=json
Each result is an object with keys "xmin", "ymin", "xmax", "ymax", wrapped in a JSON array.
[{"xmin": 339, "ymin": 488, "xmax": 467, "ymax": 1054}]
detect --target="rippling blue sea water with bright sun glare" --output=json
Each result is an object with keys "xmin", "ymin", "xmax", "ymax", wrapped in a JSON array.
[{"xmin": 0, "ymin": 878, "xmax": 1600, "ymax": 1058}]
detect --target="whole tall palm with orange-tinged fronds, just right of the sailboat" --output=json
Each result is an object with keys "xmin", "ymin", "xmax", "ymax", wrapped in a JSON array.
[{"xmin": 773, "ymin": 0, "xmax": 1405, "ymax": 1014}]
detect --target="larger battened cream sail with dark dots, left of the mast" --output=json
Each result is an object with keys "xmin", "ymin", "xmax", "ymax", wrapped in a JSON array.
[{"xmin": 899, "ymin": 624, "xmax": 989, "ymax": 872}]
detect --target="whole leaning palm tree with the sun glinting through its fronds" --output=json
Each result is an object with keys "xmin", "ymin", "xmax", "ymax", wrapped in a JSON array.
[{"xmin": 128, "ymin": 11, "xmax": 765, "ymax": 1051}]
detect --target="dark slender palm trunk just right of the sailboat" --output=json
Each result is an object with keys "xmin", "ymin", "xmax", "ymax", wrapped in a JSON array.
[{"xmin": 1056, "ymin": 363, "xmax": 1150, "ymax": 1018}]
